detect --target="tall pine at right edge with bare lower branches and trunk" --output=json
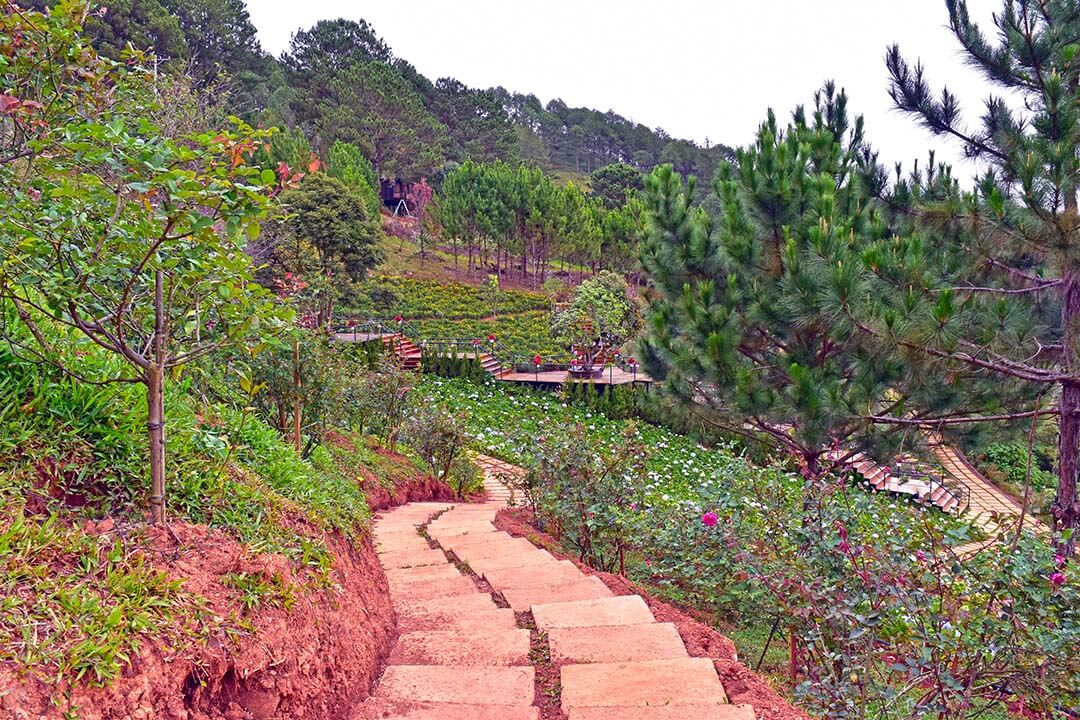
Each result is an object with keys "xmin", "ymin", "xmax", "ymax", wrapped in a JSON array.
[{"xmin": 861, "ymin": 0, "xmax": 1080, "ymax": 551}]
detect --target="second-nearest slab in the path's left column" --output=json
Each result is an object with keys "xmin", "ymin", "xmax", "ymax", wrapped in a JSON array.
[{"xmin": 375, "ymin": 665, "xmax": 535, "ymax": 707}]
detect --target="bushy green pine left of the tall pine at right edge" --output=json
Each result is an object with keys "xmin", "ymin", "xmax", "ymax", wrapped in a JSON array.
[{"xmin": 642, "ymin": 90, "xmax": 903, "ymax": 480}]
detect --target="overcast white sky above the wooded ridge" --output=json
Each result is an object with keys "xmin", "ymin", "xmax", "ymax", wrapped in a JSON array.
[{"xmin": 248, "ymin": 0, "xmax": 1000, "ymax": 180}]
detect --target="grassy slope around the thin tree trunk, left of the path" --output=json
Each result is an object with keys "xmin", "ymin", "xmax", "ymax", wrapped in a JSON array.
[{"xmin": 0, "ymin": 330, "xmax": 384, "ymax": 684}]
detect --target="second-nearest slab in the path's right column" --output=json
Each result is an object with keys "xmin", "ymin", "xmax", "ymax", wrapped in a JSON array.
[{"xmin": 562, "ymin": 657, "xmax": 728, "ymax": 712}]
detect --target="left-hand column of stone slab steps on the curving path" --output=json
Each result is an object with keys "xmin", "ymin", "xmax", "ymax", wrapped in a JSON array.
[{"xmin": 353, "ymin": 503, "xmax": 539, "ymax": 720}]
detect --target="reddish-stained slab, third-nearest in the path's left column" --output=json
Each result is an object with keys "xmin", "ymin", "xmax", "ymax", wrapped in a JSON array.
[{"xmin": 387, "ymin": 628, "xmax": 529, "ymax": 667}]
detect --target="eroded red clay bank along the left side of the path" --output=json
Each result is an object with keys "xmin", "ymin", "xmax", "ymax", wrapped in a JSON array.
[{"xmin": 0, "ymin": 475, "xmax": 450, "ymax": 720}]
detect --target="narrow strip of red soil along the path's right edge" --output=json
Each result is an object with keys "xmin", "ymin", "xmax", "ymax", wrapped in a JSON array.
[{"xmin": 495, "ymin": 510, "xmax": 810, "ymax": 720}]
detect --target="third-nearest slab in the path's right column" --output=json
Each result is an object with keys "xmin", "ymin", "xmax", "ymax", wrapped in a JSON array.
[{"xmin": 548, "ymin": 623, "xmax": 687, "ymax": 664}]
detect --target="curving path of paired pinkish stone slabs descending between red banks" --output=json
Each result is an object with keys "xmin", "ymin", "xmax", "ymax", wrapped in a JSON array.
[{"xmin": 354, "ymin": 456, "xmax": 754, "ymax": 720}]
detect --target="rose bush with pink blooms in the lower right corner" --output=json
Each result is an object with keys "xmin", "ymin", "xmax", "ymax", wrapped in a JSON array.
[{"xmin": 743, "ymin": 488, "xmax": 1080, "ymax": 718}]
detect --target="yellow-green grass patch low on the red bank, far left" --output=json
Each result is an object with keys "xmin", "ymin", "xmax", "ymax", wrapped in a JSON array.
[{"xmin": 0, "ymin": 513, "xmax": 210, "ymax": 684}]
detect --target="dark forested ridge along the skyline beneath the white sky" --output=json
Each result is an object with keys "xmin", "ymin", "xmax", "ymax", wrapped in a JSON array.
[{"xmin": 26, "ymin": 0, "xmax": 733, "ymax": 180}]
